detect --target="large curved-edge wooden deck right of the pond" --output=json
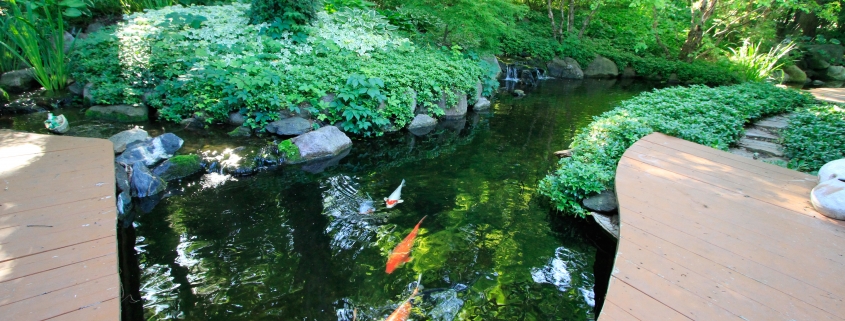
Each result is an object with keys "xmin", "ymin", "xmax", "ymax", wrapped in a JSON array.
[{"xmin": 599, "ymin": 134, "xmax": 845, "ymax": 321}]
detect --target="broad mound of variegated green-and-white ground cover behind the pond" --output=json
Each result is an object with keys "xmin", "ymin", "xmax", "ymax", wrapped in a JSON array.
[{"xmin": 73, "ymin": 3, "xmax": 489, "ymax": 135}]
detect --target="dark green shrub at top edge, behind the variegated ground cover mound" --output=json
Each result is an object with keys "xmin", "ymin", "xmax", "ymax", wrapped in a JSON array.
[{"xmin": 249, "ymin": 0, "xmax": 320, "ymax": 26}]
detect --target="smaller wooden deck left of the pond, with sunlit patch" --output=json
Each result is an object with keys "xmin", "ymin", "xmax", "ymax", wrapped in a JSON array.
[{"xmin": 0, "ymin": 130, "xmax": 120, "ymax": 321}]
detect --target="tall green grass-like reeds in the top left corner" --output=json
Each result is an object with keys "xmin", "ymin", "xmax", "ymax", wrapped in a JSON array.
[{"xmin": 0, "ymin": 0, "xmax": 71, "ymax": 91}]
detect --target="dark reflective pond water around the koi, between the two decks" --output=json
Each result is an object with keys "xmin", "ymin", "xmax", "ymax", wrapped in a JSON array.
[{"xmin": 0, "ymin": 80, "xmax": 653, "ymax": 321}]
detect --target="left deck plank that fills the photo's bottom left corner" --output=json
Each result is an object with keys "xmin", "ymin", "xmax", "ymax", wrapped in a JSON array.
[{"xmin": 0, "ymin": 273, "xmax": 120, "ymax": 320}]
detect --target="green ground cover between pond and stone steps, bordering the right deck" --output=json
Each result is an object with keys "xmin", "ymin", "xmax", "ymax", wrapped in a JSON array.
[{"xmin": 539, "ymin": 83, "xmax": 812, "ymax": 217}]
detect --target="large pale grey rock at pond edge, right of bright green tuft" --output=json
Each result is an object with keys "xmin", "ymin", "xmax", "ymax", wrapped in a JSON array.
[{"xmin": 291, "ymin": 126, "xmax": 352, "ymax": 162}]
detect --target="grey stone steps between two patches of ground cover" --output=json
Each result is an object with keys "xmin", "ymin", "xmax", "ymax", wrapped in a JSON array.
[{"xmin": 729, "ymin": 114, "xmax": 792, "ymax": 164}]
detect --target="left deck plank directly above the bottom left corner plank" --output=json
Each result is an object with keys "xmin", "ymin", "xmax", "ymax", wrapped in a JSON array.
[{"xmin": 0, "ymin": 253, "xmax": 117, "ymax": 307}]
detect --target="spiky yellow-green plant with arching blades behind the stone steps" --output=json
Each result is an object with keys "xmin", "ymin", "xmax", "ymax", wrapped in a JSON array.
[{"xmin": 728, "ymin": 38, "xmax": 795, "ymax": 81}]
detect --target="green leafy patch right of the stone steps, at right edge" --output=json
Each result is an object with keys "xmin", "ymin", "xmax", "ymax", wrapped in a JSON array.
[{"xmin": 781, "ymin": 104, "xmax": 845, "ymax": 172}]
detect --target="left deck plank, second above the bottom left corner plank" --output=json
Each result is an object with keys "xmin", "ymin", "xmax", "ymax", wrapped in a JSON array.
[{"xmin": 0, "ymin": 237, "xmax": 117, "ymax": 282}]
